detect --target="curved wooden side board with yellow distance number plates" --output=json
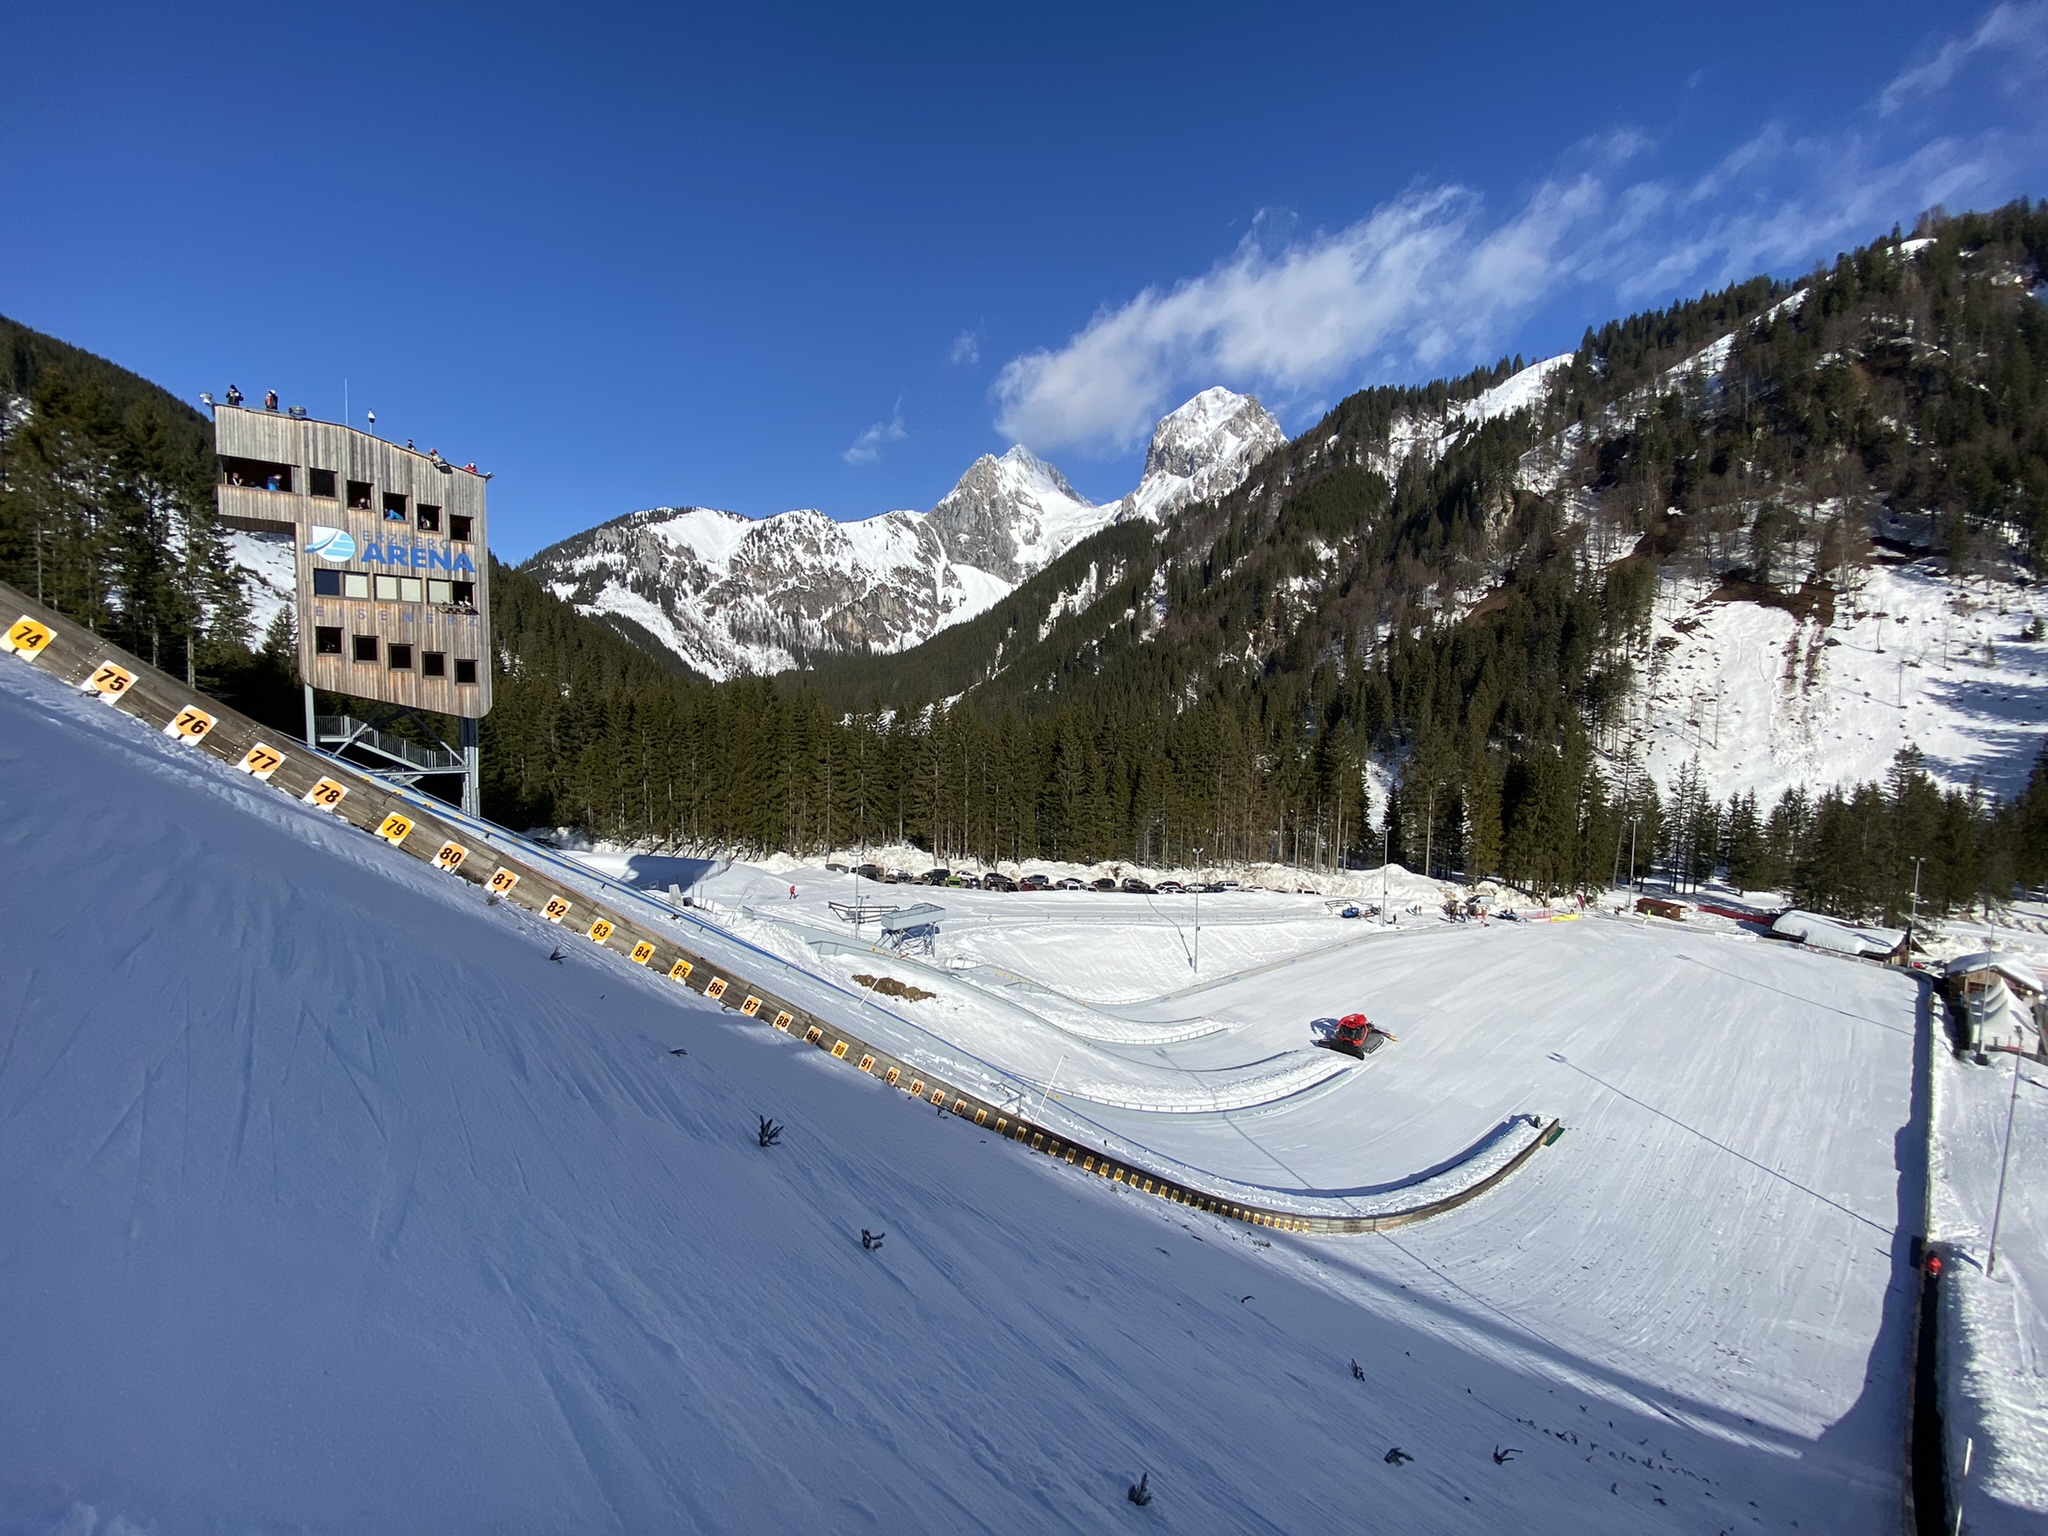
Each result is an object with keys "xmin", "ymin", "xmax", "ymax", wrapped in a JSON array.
[{"xmin": 0, "ymin": 582, "xmax": 1563, "ymax": 1233}]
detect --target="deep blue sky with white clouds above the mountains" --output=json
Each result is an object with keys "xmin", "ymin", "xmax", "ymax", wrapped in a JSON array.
[{"xmin": 0, "ymin": 0, "xmax": 2048, "ymax": 559}]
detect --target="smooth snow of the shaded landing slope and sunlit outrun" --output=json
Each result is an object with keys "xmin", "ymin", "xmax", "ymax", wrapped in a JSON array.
[{"xmin": 0, "ymin": 622, "xmax": 1949, "ymax": 1536}]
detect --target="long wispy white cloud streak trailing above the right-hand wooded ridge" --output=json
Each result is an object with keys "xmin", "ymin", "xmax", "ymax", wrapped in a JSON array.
[{"xmin": 993, "ymin": 10, "xmax": 2048, "ymax": 453}]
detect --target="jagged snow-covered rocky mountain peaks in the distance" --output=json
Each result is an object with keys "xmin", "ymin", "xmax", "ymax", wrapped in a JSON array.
[{"xmin": 526, "ymin": 389, "xmax": 1284, "ymax": 678}]
